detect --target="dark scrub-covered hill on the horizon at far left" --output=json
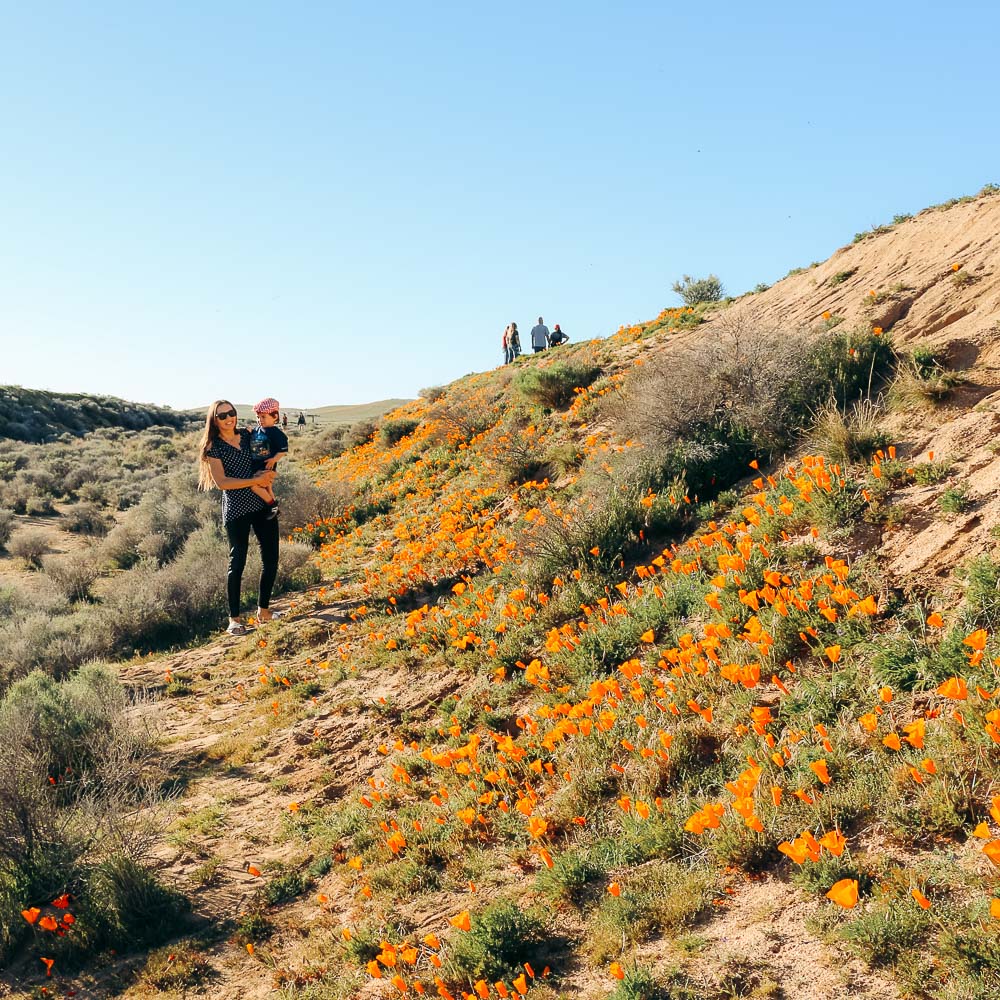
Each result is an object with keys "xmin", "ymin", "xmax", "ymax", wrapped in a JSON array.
[{"xmin": 0, "ymin": 385, "xmax": 198, "ymax": 442}]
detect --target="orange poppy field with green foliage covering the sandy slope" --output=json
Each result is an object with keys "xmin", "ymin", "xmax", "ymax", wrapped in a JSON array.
[{"xmin": 234, "ymin": 330, "xmax": 1000, "ymax": 998}]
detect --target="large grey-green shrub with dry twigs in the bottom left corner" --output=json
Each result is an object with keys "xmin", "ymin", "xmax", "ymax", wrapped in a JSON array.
[{"xmin": 0, "ymin": 665, "xmax": 176, "ymax": 961}]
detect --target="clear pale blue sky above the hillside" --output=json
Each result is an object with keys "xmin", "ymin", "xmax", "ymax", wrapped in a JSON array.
[{"xmin": 0, "ymin": 0, "xmax": 1000, "ymax": 407}]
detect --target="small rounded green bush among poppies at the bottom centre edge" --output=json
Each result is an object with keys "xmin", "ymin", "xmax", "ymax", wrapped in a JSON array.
[{"xmin": 452, "ymin": 900, "xmax": 545, "ymax": 982}]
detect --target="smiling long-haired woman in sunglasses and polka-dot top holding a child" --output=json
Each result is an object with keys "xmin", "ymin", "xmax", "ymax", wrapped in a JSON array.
[{"xmin": 198, "ymin": 399, "xmax": 279, "ymax": 635}]
